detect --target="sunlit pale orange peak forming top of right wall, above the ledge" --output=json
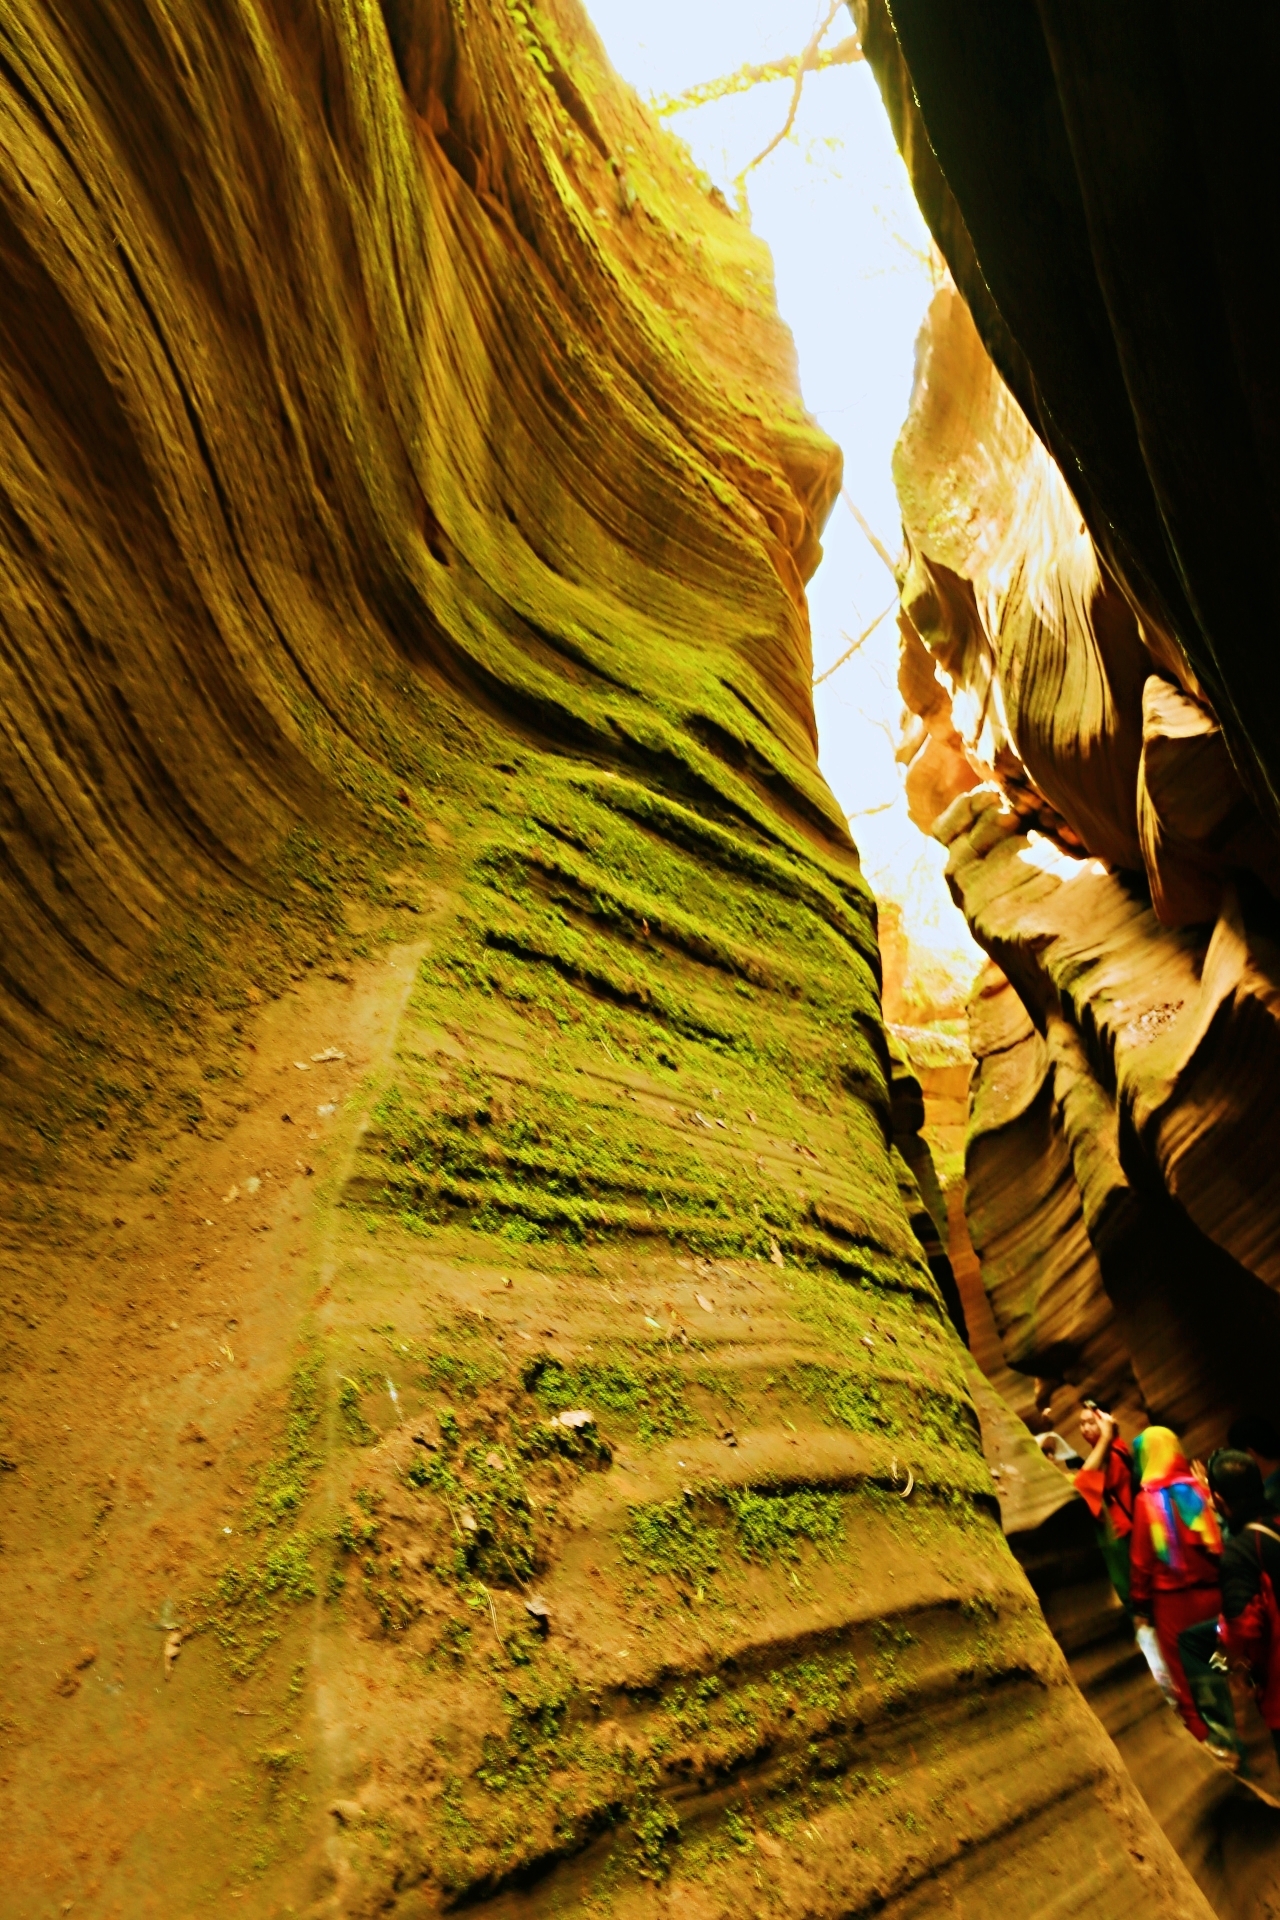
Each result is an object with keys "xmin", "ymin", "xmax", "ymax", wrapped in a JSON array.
[{"xmin": 894, "ymin": 288, "xmax": 1150, "ymax": 866}]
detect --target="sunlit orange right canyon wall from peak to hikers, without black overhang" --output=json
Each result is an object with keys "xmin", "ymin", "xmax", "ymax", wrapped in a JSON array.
[{"xmin": 896, "ymin": 290, "xmax": 1280, "ymax": 1419}]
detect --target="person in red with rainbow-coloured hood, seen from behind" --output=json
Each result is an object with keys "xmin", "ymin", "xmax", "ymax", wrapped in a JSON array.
[{"xmin": 1128, "ymin": 1427, "xmax": 1222, "ymax": 1741}]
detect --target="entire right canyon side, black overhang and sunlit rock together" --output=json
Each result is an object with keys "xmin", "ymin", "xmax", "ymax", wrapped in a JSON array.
[{"xmin": 854, "ymin": 18, "xmax": 1280, "ymax": 1916}]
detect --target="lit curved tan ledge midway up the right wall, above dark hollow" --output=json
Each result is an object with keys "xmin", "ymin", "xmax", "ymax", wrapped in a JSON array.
[{"xmin": 936, "ymin": 793, "xmax": 1280, "ymax": 1344}]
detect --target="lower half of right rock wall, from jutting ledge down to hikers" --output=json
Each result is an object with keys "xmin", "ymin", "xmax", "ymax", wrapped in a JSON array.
[{"xmin": 936, "ymin": 793, "xmax": 1280, "ymax": 1446}]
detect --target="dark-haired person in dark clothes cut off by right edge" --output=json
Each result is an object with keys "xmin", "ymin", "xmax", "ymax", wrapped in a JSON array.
[{"xmin": 1209, "ymin": 1428, "xmax": 1280, "ymax": 1759}]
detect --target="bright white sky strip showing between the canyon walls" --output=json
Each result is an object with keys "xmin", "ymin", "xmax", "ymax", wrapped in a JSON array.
[{"xmin": 585, "ymin": 0, "xmax": 977, "ymax": 970}]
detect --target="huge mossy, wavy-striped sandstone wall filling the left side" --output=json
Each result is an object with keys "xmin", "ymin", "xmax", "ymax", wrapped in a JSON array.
[{"xmin": 0, "ymin": 0, "xmax": 1205, "ymax": 1920}]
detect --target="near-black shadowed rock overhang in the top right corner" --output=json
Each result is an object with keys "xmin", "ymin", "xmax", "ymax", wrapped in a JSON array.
[{"xmin": 854, "ymin": 0, "xmax": 1280, "ymax": 826}]
